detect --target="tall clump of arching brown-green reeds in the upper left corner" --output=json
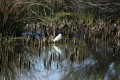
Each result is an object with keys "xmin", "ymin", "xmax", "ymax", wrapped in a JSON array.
[{"xmin": 0, "ymin": 0, "xmax": 52, "ymax": 36}]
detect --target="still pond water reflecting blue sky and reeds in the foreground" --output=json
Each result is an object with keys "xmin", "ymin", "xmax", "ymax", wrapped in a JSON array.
[{"xmin": 0, "ymin": 39, "xmax": 120, "ymax": 80}]
